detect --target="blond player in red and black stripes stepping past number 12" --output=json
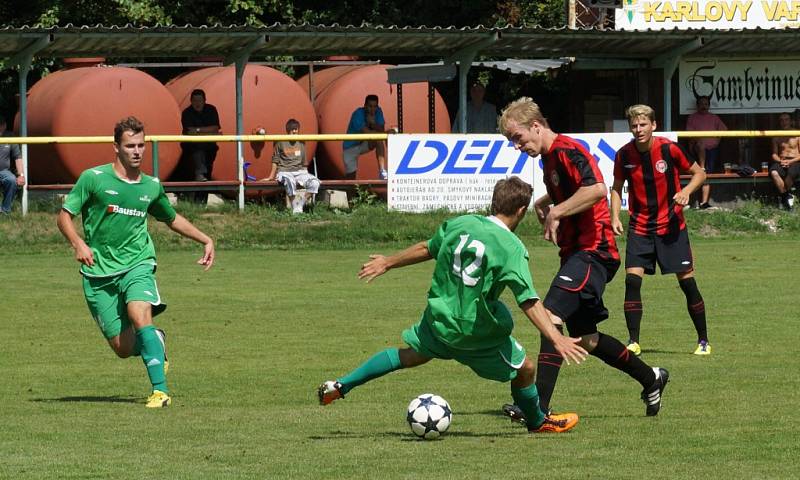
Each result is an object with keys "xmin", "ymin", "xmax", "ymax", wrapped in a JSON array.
[{"xmin": 500, "ymin": 97, "xmax": 669, "ymax": 424}]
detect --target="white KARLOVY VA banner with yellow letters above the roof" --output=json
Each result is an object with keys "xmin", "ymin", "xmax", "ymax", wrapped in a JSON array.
[{"xmin": 614, "ymin": 0, "xmax": 800, "ymax": 30}]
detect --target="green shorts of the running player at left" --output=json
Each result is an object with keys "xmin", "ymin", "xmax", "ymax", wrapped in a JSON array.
[{"xmin": 83, "ymin": 263, "xmax": 167, "ymax": 339}]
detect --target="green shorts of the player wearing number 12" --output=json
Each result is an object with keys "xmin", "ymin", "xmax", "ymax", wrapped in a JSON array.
[{"xmin": 403, "ymin": 318, "xmax": 525, "ymax": 382}]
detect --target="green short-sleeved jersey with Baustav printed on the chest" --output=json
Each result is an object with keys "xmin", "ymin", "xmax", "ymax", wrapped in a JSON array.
[{"xmin": 63, "ymin": 163, "xmax": 176, "ymax": 277}]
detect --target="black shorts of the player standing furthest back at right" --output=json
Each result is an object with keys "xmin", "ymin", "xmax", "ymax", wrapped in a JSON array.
[{"xmin": 625, "ymin": 228, "xmax": 694, "ymax": 275}]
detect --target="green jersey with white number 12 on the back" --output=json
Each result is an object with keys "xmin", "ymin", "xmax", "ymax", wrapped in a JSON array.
[{"xmin": 423, "ymin": 215, "xmax": 539, "ymax": 350}]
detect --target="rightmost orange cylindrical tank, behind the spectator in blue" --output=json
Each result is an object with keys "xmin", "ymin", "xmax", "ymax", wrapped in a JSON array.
[{"xmin": 297, "ymin": 65, "xmax": 450, "ymax": 179}]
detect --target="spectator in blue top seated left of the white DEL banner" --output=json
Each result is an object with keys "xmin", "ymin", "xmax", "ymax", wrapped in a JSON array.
[{"xmin": 342, "ymin": 94, "xmax": 388, "ymax": 180}]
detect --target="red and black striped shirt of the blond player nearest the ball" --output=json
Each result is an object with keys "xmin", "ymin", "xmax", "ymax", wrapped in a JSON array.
[{"xmin": 542, "ymin": 135, "xmax": 619, "ymax": 261}]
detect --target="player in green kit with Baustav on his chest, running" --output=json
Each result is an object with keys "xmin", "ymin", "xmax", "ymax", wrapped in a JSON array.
[{"xmin": 58, "ymin": 117, "xmax": 214, "ymax": 408}]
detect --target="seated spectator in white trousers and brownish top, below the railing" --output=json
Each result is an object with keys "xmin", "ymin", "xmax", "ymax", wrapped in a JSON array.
[{"xmin": 264, "ymin": 118, "xmax": 319, "ymax": 213}]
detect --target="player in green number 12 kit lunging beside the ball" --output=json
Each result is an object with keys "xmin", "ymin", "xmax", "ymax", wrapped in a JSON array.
[{"xmin": 318, "ymin": 177, "xmax": 586, "ymax": 432}]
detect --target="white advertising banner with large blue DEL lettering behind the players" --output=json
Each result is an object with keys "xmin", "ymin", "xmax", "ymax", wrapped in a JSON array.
[{"xmin": 388, "ymin": 132, "xmax": 677, "ymax": 212}]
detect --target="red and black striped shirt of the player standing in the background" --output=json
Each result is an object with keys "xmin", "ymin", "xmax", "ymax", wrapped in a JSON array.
[{"xmin": 614, "ymin": 137, "xmax": 692, "ymax": 235}]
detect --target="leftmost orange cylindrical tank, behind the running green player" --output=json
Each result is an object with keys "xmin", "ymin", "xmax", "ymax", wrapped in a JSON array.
[{"xmin": 15, "ymin": 67, "xmax": 181, "ymax": 184}]
